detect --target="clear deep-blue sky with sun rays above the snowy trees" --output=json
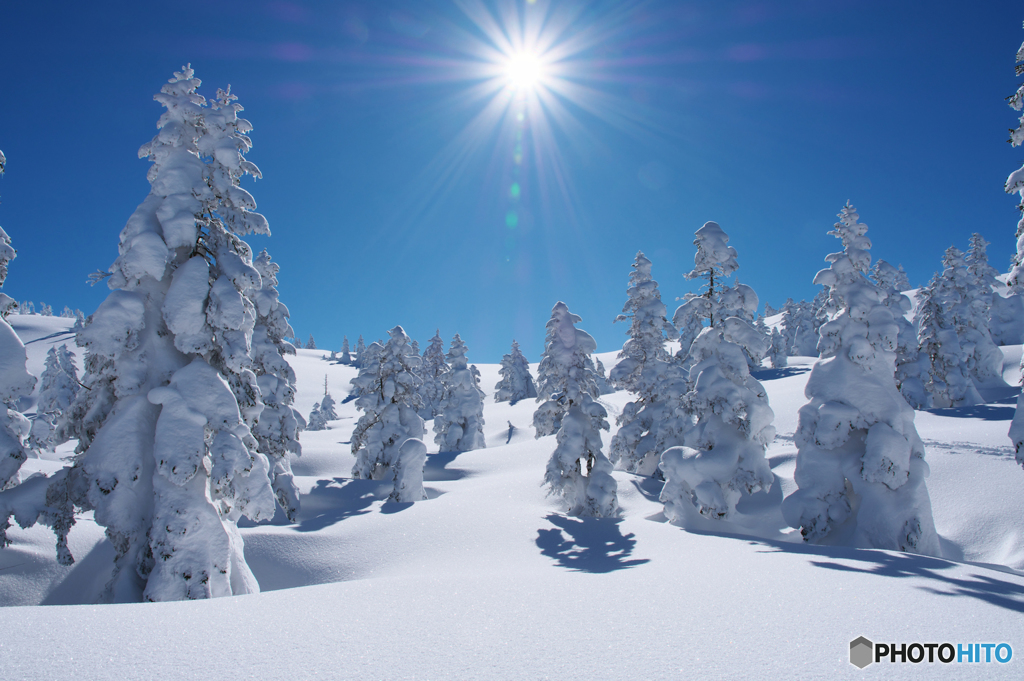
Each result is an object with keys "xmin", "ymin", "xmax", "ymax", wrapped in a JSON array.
[{"xmin": 0, "ymin": 0, "xmax": 1024, "ymax": 361}]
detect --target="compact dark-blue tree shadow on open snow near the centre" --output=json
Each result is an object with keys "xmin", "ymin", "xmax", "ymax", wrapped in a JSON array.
[{"xmin": 537, "ymin": 513, "xmax": 650, "ymax": 573}]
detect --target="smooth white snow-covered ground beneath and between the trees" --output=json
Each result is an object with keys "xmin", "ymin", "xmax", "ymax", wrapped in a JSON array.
[{"xmin": 0, "ymin": 316, "xmax": 1024, "ymax": 680}]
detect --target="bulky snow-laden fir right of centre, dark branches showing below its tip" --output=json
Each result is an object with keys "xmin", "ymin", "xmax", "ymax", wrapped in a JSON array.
[{"xmin": 659, "ymin": 222, "xmax": 775, "ymax": 521}]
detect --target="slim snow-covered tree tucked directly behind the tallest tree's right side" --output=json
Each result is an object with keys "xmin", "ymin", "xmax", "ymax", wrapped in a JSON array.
[{"xmin": 250, "ymin": 249, "xmax": 306, "ymax": 522}]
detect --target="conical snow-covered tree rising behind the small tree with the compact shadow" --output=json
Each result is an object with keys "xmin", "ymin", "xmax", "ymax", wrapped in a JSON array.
[{"xmin": 534, "ymin": 301, "xmax": 600, "ymax": 437}]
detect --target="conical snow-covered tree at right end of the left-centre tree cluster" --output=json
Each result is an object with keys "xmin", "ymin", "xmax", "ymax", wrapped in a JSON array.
[{"xmin": 434, "ymin": 334, "xmax": 487, "ymax": 452}]
